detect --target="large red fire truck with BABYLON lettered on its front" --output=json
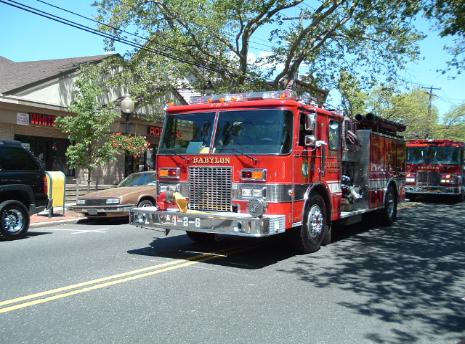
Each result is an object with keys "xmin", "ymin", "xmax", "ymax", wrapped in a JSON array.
[{"xmin": 130, "ymin": 90, "xmax": 405, "ymax": 253}]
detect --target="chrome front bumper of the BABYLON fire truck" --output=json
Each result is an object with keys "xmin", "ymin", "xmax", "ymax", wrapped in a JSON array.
[{"xmin": 129, "ymin": 207, "xmax": 286, "ymax": 237}]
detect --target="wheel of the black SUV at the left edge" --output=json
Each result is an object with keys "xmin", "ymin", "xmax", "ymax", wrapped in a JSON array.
[{"xmin": 0, "ymin": 200, "xmax": 29, "ymax": 240}]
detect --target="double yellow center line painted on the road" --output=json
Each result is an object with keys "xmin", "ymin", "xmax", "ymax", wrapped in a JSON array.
[{"xmin": 0, "ymin": 246, "xmax": 252, "ymax": 314}]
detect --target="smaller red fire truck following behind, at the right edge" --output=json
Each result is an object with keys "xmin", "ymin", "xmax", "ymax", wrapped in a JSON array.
[{"xmin": 405, "ymin": 140, "xmax": 465, "ymax": 200}]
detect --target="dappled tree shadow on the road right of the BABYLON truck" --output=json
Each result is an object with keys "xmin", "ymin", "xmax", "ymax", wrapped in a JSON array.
[{"xmin": 281, "ymin": 203, "xmax": 465, "ymax": 343}]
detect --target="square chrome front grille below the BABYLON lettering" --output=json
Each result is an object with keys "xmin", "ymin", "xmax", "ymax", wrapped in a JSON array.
[{"xmin": 189, "ymin": 166, "xmax": 232, "ymax": 211}]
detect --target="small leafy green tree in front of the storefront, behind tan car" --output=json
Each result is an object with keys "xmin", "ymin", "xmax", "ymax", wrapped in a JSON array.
[{"xmin": 56, "ymin": 65, "xmax": 145, "ymax": 191}]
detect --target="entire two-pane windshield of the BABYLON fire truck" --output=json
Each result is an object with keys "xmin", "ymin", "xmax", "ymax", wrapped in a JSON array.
[{"xmin": 158, "ymin": 109, "xmax": 292, "ymax": 154}]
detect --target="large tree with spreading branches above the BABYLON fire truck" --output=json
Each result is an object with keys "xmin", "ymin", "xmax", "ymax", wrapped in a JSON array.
[{"xmin": 96, "ymin": 0, "xmax": 422, "ymax": 95}]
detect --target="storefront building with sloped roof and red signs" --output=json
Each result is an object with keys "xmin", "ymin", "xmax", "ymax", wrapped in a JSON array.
[{"xmin": 0, "ymin": 55, "xmax": 193, "ymax": 184}]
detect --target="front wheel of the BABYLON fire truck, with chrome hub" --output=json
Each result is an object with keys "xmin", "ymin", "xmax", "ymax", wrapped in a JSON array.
[{"xmin": 290, "ymin": 194, "xmax": 331, "ymax": 253}]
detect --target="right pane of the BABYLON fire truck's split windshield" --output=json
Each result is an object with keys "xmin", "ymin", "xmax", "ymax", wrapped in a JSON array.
[{"xmin": 213, "ymin": 109, "xmax": 292, "ymax": 154}]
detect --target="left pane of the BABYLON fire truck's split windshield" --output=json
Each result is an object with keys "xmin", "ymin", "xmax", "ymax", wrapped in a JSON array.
[{"xmin": 158, "ymin": 112, "xmax": 215, "ymax": 154}]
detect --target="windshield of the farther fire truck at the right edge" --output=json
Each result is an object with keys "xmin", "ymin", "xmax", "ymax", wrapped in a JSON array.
[{"xmin": 407, "ymin": 146, "xmax": 460, "ymax": 165}]
